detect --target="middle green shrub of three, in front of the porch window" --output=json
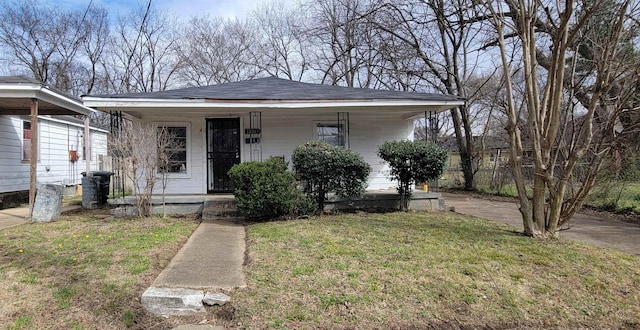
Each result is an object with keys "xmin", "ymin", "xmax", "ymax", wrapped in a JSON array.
[{"xmin": 291, "ymin": 141, "xmax": 371, "ymax": 211}]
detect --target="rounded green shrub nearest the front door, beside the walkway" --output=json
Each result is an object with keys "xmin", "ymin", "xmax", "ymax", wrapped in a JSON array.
[{"xmin": 229, "ymin": 158, "xmax": 301, "ymax": 220}]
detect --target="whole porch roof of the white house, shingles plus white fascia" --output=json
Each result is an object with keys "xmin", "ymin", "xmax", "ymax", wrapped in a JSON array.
[{"xmin": 83, "ymin": 77, "xmax": 464, "ymax": 117}]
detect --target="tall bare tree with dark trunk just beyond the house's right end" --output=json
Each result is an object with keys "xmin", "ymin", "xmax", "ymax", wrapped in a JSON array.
[{"xmin": 372, "ymin": 0, "xmax": 488, "ymax": 189}]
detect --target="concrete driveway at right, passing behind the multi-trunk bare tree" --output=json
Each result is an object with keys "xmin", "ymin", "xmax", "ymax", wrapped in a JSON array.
[{"xmin": 442, "ymin": 192, "xmax": 640, "ymax": 256}]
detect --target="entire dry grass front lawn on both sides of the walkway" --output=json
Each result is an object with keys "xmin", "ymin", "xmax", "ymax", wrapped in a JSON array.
[{"xmin": 0, "ymin": 210, "xmax": 640, "ymax": 329}]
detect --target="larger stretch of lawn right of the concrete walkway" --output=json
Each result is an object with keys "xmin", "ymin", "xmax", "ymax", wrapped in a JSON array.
[{"xmin": 231, "ymin": 213, "xmax": 640, "ymax": 329}]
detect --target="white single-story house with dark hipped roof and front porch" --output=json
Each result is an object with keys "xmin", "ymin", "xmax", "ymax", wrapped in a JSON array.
[{"xmin": 83, "ymin": 77, "xmax": 464, "ymax": 194}]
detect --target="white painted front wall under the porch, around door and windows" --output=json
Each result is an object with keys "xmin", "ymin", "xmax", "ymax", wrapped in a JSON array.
[{"xmin": 147, "ymin": 112, "xmax": 413, "ymax": 194}]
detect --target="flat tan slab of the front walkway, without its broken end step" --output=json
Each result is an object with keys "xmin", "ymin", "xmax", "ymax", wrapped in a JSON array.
[{"xmin": 153, "ymin": 222, "xmax": 246, "ymax": 290}]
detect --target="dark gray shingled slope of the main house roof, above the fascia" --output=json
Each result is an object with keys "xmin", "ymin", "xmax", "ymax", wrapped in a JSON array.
[{"xmin": 91, "ymin": 77, "xmax": 462, "ymax": 102}]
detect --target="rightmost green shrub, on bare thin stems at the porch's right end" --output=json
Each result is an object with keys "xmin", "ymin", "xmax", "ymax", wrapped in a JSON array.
[{"xmin": 378, "ymin": 140, "xmax": 448, "ymax": 211}]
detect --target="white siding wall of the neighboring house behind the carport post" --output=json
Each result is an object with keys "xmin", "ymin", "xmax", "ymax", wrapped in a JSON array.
[{"xmin": 0, "ymin": 116, "xmax": 107, "ymax": 193}]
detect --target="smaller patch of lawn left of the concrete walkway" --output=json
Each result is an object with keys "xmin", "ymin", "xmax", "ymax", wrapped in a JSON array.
[{"xmin": 0, "ymin": 210, "xmax": 197, "ymax": 329}]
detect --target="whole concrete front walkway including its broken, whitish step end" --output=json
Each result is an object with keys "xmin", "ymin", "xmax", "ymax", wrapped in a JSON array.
[{"xmin": 141, "ymin": 221, "xmax": 246, "ymax": 320}]
